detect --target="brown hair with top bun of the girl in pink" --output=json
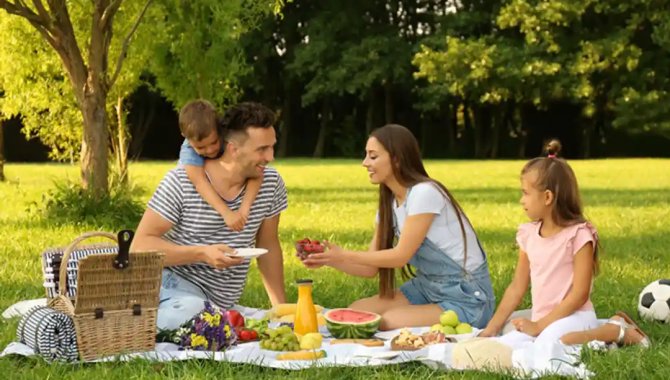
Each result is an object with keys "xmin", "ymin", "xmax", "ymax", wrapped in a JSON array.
[{"xmin": 521, "ymin": 139, "xmax": 600, "ymax": 274}]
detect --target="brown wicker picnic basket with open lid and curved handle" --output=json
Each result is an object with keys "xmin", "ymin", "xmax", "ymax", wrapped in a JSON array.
[{"xmin": 49, "ymin": 230, "xmax": 164, "ymax": 360}]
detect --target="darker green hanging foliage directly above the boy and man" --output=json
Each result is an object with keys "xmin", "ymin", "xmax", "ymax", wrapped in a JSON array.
[{"xmin": 147, "ymin": 0, "xmax": 283, "ymax": 109}]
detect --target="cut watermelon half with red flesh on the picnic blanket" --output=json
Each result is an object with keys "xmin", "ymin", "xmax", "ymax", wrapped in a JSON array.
[{"xmin": 323, "ymin": 309, "xmax": 382, "ymax": 339}]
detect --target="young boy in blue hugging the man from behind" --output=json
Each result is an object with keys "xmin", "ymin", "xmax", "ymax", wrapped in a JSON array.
[{"xmin": 179, "ymin": 99, "xmax": 262, "ymax": 231}]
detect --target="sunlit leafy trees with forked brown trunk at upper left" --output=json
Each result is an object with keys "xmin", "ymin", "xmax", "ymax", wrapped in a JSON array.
[{"xmin": 0, "ymin": 0, "xmax": 284, "ymax": 193}]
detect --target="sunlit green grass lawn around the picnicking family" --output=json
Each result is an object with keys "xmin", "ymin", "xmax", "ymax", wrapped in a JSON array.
[{"xmin": 0, "ymin": 159, "xmax": 670, "ymax": 379}]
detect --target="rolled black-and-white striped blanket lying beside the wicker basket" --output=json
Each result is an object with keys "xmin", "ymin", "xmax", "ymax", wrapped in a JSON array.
[{"xmin": 16, "ymin": 306, "xmax": 79, "ymax": 362}]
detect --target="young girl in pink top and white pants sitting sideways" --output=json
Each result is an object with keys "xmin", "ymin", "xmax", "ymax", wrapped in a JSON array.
[{"xmin": 479, "ymin": 140, "xmax": 643, "ymax": 348}]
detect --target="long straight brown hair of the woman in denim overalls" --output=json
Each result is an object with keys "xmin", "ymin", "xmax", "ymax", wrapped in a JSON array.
[{"xmin": 370, "ymin": 124, "xmax": 468, "ymax": 298}]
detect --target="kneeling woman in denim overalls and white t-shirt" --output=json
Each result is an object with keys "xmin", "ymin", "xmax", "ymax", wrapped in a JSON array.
[{"xmin": 303, "ymin": 125, "xmax": 495, "ymax": 330}]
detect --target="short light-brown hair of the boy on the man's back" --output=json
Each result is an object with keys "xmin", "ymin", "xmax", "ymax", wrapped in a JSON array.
[{"xmin": 179, "ymin": 99, "xmax": 218, "ymax": 141}]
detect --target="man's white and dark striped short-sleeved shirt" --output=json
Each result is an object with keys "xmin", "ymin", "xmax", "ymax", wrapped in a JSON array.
[{"xmin": 148, "ymin": 166, "xmax": 288, "ymax": 308}]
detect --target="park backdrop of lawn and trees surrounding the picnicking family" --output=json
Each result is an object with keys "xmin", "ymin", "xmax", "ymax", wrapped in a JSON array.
[{"xmin": 0, "ymin": 0, "xmax": 670, "ymax": 379}]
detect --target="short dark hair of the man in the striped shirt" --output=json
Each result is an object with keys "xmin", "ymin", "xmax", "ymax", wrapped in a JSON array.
[{"xmin": 220, "ymin": 102, "xmax": 275, "ymax": 140}]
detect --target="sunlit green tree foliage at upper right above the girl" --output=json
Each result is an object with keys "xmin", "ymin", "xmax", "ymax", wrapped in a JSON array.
[{"xmin": 414, "ymin": 0, "xmax": 670, "ymax": 152}]
